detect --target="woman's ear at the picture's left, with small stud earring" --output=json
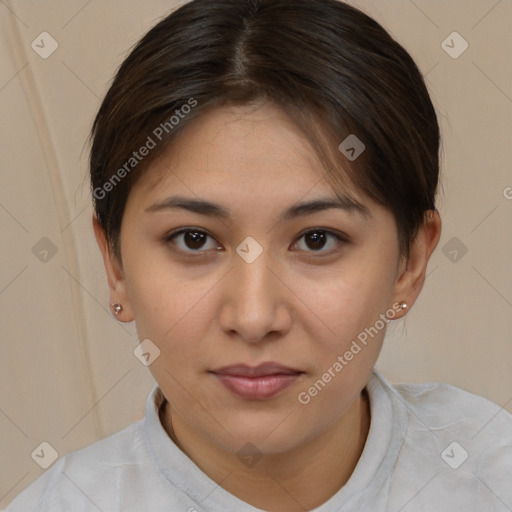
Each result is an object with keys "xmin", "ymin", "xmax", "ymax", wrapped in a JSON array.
[{"xmin": 92, "ymin": 213, "xmax": 134, "ymax": 322}]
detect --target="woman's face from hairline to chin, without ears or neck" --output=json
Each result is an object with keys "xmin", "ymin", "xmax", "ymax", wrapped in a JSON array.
[{"xmin": 111, "ymin": 102, "xmax": 406, "ymax": 453}]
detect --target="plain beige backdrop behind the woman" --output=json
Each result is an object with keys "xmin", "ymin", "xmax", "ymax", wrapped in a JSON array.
[{"xmin": 0, "ymin": 0, "xmax": 512, "ymax": 506}]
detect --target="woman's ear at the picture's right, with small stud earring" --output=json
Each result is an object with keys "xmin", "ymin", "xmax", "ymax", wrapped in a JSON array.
[{"xmin": 394, "ymin": 210, "xmax": 441, "ymax": 318}]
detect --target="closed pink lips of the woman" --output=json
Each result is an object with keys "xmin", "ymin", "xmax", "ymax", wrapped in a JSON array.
[{"xmin": 213, "ymin": 363, "xmax": 304, "ymax": 400}]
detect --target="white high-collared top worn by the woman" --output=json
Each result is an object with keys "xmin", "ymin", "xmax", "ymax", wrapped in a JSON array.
[{"xmin": 6, "ymin": 370, "xmax": 512, "ymax": 512}]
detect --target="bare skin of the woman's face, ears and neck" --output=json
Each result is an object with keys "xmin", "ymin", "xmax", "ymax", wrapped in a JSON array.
[{"xmin": 93, "ymin": 104, "xmax": 441, "ymax": 511}]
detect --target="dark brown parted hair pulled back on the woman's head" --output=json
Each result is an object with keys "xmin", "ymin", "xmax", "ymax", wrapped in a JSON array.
[{"xmin": 90, "ymin": 0, "xmax": 440, "ymax": 263}]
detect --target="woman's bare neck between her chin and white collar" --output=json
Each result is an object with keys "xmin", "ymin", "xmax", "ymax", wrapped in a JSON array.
[{"xmin": 161, "ymin": 390, "xmax": 370, "ymax": 512}]
